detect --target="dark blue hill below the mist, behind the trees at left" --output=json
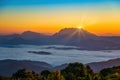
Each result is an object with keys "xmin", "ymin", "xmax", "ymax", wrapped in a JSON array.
[{"xmin": 0, "ymin": 60, "xmax": 53, "ymax": 76}]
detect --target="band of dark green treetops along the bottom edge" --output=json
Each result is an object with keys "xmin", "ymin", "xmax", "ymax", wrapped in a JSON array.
[{"xmin": 0, "ymin": 63, "xmax": 120, "ymax": 80}]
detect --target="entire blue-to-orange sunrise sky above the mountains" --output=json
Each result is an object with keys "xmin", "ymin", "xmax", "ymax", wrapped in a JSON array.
[{"xmin": 0, "ymin": 0, "xmax": 120, "ymax": 36}]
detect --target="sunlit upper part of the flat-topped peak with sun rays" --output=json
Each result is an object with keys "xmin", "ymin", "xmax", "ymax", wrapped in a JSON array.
[{"xmin": 54, "ymin": 28, "xmax": 96, "ymax": 39}]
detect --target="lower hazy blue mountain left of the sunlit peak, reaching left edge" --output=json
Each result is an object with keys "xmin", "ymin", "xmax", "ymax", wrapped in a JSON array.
[{"xmin": 0, "ymin": 31, "xmax": 49, "ymax": 46}]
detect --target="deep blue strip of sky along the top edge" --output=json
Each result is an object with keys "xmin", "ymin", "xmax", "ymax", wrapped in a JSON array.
[{"xmin": 0, "ymin": 0, "xmax": 120, "ymax": 6}]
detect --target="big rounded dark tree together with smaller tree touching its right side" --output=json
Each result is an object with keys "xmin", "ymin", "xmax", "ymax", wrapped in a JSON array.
[{"xmin": 62, "ymin": 63, "xmax": 93, "ymax": 80}]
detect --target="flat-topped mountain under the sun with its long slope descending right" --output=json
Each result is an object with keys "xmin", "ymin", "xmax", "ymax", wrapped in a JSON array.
[{"xmin": 52, "ymin": 28, "xmax": 120, "ymax": 50}]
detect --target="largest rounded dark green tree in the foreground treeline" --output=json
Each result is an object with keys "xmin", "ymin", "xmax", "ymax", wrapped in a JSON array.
[{"xmin": 62, "ymin": 62, "xmax": 87, "ymax": 80}]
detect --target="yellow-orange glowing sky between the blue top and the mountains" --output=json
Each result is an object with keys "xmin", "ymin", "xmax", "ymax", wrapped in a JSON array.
[{"xmin": 0, "ymin": 4, "xmax": 120, "ymax": 35}]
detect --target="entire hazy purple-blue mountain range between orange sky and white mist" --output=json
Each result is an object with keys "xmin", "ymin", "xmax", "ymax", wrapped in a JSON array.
[{"xmin": 0, "ymin": 28, "xmax": 120, "ymax": 50}]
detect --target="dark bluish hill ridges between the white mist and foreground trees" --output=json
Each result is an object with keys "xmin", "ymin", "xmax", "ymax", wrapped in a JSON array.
[{"xmin": 0, "ymin": 58, "xmax": 120, "ymax": 76}]
